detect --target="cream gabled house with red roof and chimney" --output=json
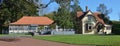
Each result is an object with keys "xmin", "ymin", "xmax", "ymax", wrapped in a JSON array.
[{"xmin": 77, "ymin": 7, "xmax": 112, "ymax": 34}]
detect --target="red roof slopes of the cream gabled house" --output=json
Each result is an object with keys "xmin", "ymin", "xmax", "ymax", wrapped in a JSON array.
[{"xmin": 77, "ymin": 11, "xmax": 105, "ymax": 25}]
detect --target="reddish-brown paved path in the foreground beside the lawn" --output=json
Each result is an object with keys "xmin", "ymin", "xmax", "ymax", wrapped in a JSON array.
[{"xmin": 0, "ymin": 38, "xmax": 78, "ymax": 46}]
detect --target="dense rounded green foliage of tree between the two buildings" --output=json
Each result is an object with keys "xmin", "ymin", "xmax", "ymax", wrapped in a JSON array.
[{"xmin": 54, "ymin": 8, "xmax": 73, "ymax": 28}]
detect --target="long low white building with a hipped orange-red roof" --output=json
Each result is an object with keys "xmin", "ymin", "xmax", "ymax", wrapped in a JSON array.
[{"xmin": 9, "ymin": 16, "xmax": 54, "ymax": 34}]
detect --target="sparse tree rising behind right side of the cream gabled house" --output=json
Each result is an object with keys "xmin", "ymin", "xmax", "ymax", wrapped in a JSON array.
[{"xmin": 97, "ymin": 4, "xmax": 112, "ymax": 24}]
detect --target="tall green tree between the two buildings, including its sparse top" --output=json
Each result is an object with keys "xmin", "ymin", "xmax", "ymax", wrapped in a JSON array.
[{"xmin": 54, "ymin": 0, "xmax": 73, "ymax": 28}]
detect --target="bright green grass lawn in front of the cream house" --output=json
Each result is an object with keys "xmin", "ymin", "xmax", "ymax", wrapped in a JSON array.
[{"xmin": 33, "ymin": 35, "xmax": 120, "ymax": 46}]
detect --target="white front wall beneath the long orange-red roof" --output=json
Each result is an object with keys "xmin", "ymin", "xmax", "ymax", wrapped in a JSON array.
[{"xmin": 9, "ymin": 25, "xmax": 38, "ymax": 34}]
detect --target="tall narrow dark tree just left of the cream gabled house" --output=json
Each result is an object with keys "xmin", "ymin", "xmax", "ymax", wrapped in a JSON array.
[{"xmin": 71, "ymin": 0, "xmax": 83, "ymax": 33}]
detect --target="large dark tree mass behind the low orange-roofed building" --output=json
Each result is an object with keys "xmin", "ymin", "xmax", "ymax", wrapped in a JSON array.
[{"xmin": 0, "ymin": 0, "xmax": 38, "ymax": 33}]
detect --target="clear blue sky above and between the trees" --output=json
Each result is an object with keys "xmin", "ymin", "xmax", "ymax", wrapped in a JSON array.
[{"xmin": 42, "ymin": 0, "xmax": 120, "ymax": 20}]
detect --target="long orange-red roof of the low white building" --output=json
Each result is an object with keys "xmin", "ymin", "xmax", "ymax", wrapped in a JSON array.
[{"xmin": 11, "ymin": 16, "xmax": 53, "ymax": 25}]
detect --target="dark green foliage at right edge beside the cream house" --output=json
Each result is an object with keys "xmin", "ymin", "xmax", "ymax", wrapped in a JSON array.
[{"xmin": 112, "ymin": 21, "xmax": 120, "ymax": 35}]
